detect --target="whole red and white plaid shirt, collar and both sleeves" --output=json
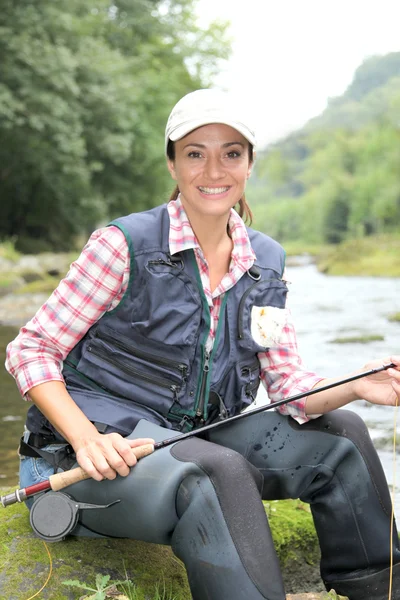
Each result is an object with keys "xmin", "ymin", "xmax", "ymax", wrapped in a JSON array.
[{"xmin": 6, "ymin": 198, "xmax": 322, "ymax": 423}]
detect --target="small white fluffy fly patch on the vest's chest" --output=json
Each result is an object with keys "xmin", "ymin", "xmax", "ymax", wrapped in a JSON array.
[{"xmin": 251, "ymin": 306, "xmax": 287, "ymax": 348}]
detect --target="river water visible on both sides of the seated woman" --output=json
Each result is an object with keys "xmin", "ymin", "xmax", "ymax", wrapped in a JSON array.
[{"xmin": 0, "ymin": 264, "xmax": 400, "ymax": 510}]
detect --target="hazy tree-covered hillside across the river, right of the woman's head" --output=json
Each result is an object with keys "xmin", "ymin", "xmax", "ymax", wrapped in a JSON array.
[{"xmin": 248, "ymin": 48, "xmax": 400, "ymax": 252}]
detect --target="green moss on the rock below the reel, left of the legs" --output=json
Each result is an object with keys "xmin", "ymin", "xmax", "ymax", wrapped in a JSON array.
[{"xmin": 0, "ymin": 496, "xmax": 190, "ymax": 600}]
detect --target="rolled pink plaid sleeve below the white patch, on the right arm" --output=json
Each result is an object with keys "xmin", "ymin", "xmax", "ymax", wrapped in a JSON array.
[{"xmin": 258, "ymin": 309, "xmax": 324, "ymax": 424}]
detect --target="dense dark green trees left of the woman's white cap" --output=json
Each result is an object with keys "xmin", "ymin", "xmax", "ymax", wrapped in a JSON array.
[{"xmin": 0, "ymin": 0, "xmax": 229, "ymax": 251}]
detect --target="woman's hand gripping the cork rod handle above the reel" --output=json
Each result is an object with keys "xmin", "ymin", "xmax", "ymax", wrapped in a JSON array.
[{"xmin": 73, "ymin": 433, "xmax": 155, "ymax": 481}]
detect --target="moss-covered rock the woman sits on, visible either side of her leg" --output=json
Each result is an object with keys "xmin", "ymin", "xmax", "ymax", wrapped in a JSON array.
[{"xmin": 0, "ymin": 490, "xmax": 344, "ymax": 600}]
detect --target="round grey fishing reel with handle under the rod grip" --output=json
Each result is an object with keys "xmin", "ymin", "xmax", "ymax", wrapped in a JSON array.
[{"xmin": 30, "ymin": 492, "xmax": 119, "ymax": 542}]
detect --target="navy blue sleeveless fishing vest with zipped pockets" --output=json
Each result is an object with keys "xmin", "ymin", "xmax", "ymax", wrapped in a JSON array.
[{"xmin": 27, "ymin": 204, "xmax": 287, "ymax": 435}]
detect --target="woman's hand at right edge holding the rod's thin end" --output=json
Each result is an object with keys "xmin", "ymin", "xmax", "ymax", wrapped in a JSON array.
[{"xmin": 354, "ymin": 355, "xmax": 400, "ymax": 406}]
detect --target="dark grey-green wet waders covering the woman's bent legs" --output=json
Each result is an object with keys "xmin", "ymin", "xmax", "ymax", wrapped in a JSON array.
[{"xmin": 24, "ymin": 409, "xmax": 400, "ymax": 600}]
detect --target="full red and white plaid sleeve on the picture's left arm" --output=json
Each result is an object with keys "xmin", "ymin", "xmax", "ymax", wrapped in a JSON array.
[{"xmin": 5, "ymin": 226, "xmax": 130, "ymax": 399}]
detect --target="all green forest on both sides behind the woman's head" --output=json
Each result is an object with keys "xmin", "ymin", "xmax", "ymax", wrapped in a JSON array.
[{"xmin": 0, "ymin": 0, "xmax": 400, "ymax": 253}]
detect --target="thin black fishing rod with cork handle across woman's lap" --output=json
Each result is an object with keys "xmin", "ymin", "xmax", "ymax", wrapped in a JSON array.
[{"xmin": 0, "ymin": 363, "xmax": 396, "ymax": 508}]
